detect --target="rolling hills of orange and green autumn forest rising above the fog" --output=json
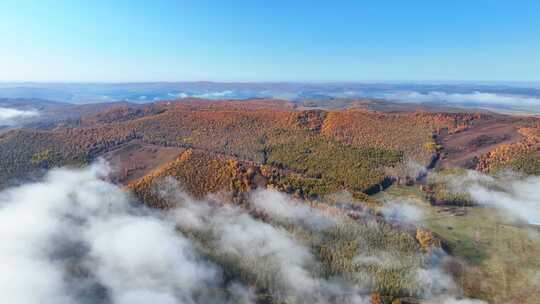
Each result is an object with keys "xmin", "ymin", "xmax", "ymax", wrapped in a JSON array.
[{"xmin": 0, "ymin": 99, "xmax": 540, "ymax": 303}]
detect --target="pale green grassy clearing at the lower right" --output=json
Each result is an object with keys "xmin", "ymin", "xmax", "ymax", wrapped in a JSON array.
[{"xmin": 378, "ymin": 186, "xmax": 540, "ymax": 304}]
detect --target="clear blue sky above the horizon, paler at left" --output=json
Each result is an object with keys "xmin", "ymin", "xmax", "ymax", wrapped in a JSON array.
[{"xmin": 0, "ymin": 0, "xmax": 540, "ymax": 82}]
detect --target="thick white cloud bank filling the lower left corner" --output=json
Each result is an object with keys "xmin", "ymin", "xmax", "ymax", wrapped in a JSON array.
[{"xmin": 0, "ymin": 163, "xmax": 224, "ymax": 304}]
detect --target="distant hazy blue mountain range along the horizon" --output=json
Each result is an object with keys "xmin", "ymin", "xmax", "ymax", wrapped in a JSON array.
[{"xmin": 0, "ymin": 82, "xmax": 540, "ymax": 114}]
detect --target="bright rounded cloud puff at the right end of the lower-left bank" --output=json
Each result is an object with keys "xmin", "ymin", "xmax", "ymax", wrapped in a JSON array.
[{"xmin": 85, "ymin": 216, "xmax": 217, "ymax": 303}]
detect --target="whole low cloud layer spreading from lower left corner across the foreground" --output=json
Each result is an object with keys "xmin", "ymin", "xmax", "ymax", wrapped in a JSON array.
[{"xmin": 0, "ymin": 162, "xmax": 490, "ymax": 304}]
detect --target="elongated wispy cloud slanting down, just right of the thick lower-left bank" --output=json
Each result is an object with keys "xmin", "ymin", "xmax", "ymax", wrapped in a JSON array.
[{"xmin": 171, "ymin": 191, "xmax": 320, "ymax": 295}]
